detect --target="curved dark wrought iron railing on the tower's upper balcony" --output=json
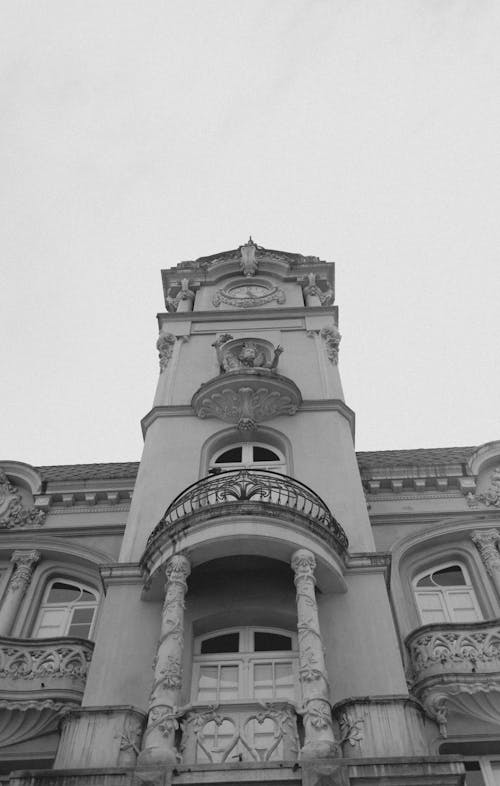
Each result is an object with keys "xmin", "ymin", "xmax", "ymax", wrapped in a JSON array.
[{"xmin": 146, "ymin": 469, "xmax": 348, "ymax": 551}]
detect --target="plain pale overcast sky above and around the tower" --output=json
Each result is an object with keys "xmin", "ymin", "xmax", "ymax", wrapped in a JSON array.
[{"xmin": 0, "ymin": 0, "xmax": 500, "ymax": 465}]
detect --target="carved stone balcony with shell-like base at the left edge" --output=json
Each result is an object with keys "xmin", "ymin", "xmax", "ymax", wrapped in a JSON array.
[{"xmin": 0, "ymin": 637, "xmax": 94, "ymax": 747}]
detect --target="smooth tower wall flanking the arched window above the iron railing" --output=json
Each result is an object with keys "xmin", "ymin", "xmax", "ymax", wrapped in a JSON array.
[{"xmin": 120, "ymin": 404, "xmax": 373, "ymax": 562}]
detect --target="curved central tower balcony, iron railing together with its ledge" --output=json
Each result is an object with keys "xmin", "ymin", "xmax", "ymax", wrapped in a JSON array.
[{"xmin": 142, "ymin": 469, "xmax": 348, "ymax": 572}]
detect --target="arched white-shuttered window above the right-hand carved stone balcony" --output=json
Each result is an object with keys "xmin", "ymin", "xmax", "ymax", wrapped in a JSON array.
[{"xmin": 413, "ymin": 563, "xmax": 483, "ymax": 625}]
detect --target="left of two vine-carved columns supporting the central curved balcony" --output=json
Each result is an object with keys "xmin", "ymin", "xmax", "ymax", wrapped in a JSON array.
[{"xmin": 138, "ymin": 554, "xmax": 191, "ymax": 767}]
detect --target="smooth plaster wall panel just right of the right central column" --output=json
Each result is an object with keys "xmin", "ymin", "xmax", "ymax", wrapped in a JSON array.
[{"xmin": 318, "ymin": 572, "xmax": 408, "ymax": 704}]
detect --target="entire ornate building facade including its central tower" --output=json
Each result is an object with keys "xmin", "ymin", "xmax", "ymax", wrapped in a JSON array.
[{"xmin": 0, "ymin": 239, "xmax": 500, "ymax": 786}]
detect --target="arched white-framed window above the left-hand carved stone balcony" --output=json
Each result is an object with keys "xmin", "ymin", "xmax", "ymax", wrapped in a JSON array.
[{"xmin": 33, "ymin": 578, "xmax": 99, "ymax": 639}]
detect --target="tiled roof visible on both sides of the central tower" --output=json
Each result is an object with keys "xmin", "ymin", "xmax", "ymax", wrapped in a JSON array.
[{"xmin": 36, "ymin": 446, "xmax": 476, "ymax": 481}]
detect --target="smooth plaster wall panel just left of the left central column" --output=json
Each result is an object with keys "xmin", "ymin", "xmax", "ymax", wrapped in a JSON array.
[{"xmin": 82, "ymin": 583, "xmax": 161, "ymax": 710}]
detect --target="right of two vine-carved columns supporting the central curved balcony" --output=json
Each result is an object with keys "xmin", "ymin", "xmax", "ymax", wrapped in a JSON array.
[{"xmin": 291, "ymin": 549, "xmax": 339, "ymax": 759}]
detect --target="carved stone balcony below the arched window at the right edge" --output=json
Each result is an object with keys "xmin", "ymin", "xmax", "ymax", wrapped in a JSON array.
[{"xmin": 406, "ymin": 619, "xmax": 500, "ymax": 736}]
